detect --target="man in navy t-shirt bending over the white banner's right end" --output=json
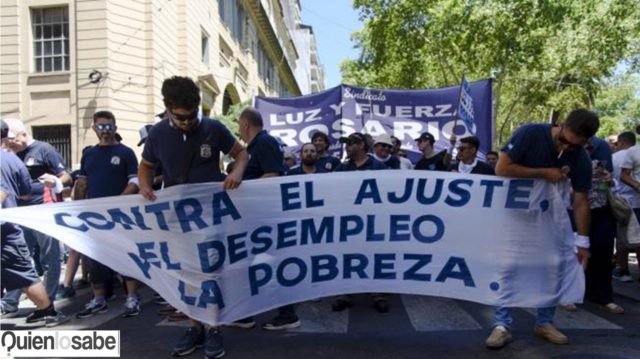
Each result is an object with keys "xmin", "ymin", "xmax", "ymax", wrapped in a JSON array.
[{"xmin": 486, "ymin": 109, "xmax": 600, "ymax": 349}]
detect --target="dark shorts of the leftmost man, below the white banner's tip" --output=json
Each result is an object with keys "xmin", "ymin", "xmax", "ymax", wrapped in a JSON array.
[{"xmin": 0, "ymin": 239, "xmax": 40, "ymax": 290}]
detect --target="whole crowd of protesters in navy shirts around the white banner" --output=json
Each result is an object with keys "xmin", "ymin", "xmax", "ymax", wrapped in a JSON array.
[{"xmin": 0, "ymin": 76, "xmax": 640, "ymax": 358}]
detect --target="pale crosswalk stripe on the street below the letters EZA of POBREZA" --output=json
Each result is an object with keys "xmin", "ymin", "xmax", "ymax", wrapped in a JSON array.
[{"xmin": 401, "ymin": 295, "xmax": 482, "ymax": 332}]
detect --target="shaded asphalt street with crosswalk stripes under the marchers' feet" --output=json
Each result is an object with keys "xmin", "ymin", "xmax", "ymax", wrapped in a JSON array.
[{"xmin": 1, "ymin": 265, "xmax": 640, "ymax": 359}]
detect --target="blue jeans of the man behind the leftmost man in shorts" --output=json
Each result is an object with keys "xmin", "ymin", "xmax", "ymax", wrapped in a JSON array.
[{"xmin": 2, "ymin": 227, "xmax": 62, "ymax": 310}]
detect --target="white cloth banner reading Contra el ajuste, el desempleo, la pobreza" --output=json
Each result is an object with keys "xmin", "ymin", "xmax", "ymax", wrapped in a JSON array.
[{"xmin": 0, "ymin": 170, "xmax": 584, "ymax": 325}]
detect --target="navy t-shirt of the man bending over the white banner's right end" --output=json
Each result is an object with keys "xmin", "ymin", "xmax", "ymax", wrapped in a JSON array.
[{"xmin": 501, "ymin": 123, "xmax": 591, "ymax": 193}]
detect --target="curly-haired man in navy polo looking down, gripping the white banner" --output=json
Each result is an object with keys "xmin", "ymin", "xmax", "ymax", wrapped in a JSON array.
[{"xmin": 138, "ymin": 76, "xmax": 248, "ymax": 358}]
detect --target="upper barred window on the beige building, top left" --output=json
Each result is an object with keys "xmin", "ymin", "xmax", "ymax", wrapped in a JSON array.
[{"xmin": 31, "ymin": 6, "xmax": 69, "ymax": 72}]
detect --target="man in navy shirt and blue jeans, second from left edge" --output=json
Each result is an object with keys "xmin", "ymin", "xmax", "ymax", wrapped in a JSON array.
[{"xmin": 2, "ymin": 119, "xmax": 72, "ymax": 312}]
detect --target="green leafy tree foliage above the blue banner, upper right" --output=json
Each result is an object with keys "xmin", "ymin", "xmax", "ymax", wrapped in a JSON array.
[{"xmin": 341, "ymin": 0, "xmax": 640, "ymax": 143}]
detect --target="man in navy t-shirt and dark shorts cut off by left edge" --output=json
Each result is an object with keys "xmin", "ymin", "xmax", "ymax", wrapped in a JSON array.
[{"xmin": 0, "ymin": 120, "xmax": 69, "ymax": 327}]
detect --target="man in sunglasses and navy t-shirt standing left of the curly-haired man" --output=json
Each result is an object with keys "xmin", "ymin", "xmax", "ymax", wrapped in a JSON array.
[{"xmin": 74, "ymin": 111, "xmax": 140, "ymax": 319}]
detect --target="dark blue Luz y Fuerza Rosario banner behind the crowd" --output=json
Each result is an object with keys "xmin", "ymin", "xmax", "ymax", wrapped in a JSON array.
[{"xmin": 255, "ymin": 79, "xmax": 492, "ymax": 162}]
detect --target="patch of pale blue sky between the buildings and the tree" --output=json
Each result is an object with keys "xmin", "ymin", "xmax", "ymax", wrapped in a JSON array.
[{"xmin": 300, "ymin": 0, "xmax": 363, "ymax": 88}]
